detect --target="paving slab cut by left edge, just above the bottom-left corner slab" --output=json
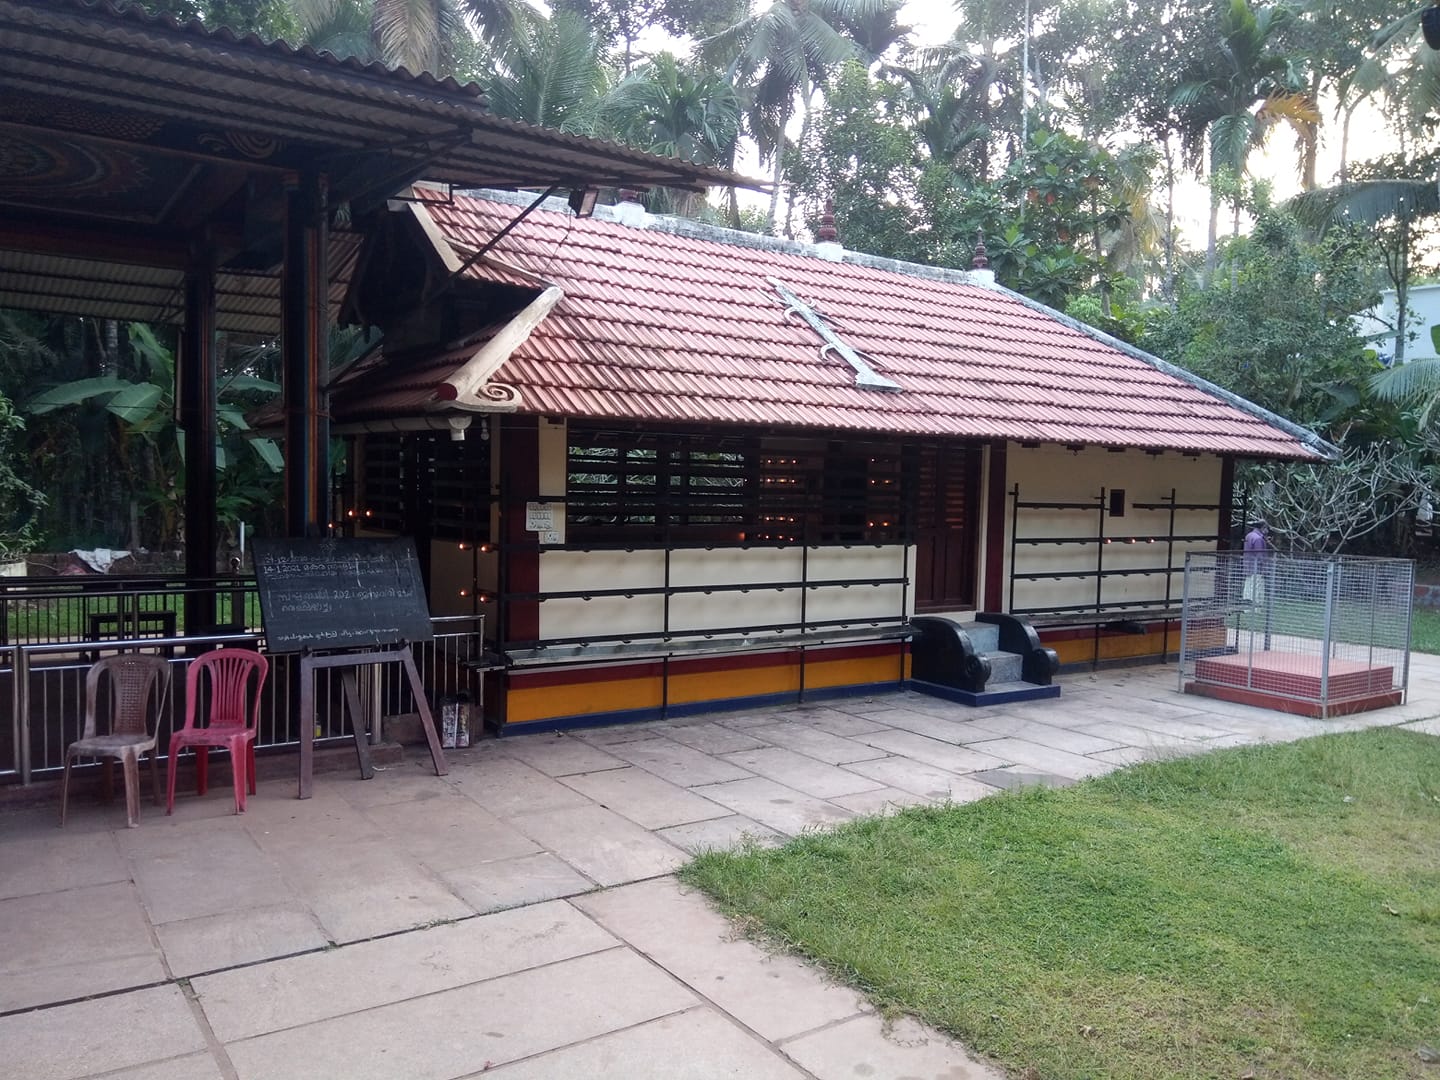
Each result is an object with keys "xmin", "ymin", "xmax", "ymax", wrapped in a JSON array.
[{"xmin": 0, "ymin": 881, "xmax": 166, "ymax": 1009}]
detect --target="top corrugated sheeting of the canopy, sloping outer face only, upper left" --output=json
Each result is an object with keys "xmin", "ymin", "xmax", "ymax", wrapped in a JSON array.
[{"xmin": 0, "ymin": 0, "xmax": 750, "ymax": 190}]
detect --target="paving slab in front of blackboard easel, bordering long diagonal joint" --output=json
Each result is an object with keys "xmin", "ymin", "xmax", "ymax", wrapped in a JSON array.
[{"xmin": 262, "ymin": 838, "xmax": 474, "ymax": 942}]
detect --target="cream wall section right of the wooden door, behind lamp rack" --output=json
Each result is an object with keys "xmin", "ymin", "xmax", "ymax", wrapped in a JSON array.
[{"xmin": 1004, "ymin": 444, "xmax": 1221, "ymax": 609}]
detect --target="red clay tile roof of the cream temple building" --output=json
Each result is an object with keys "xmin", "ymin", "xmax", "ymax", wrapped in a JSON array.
[{"xmin": 374, "ymin": 192, "xmax": 1333, "ymax": 459}]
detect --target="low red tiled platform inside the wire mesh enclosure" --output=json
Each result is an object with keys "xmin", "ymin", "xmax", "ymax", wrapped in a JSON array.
[{"xmin": 1185, "ymin": 652, "xmax": 1404, "ymax": 717}]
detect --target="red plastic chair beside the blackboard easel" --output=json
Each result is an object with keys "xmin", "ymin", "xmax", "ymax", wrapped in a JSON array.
[{"xmin": 166, "ymin": 649, "xmax": 269, "ymax": 814}]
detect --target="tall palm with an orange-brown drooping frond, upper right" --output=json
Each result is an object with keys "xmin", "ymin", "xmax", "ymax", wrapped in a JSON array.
[{"xmin": 1172, "ymin": 0, "xmax": 1320, "ymax": 278}]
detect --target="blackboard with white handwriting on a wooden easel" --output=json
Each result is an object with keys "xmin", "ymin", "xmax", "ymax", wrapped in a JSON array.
[{"xmin": 255, "ymin": 537, "xmax": 432, "ymax": 652}]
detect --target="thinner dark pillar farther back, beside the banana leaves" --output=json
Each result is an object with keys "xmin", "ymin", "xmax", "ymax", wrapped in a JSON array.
[{"xmin": 176, "ymin": 239, "xmax": 217, "ymax": 634}]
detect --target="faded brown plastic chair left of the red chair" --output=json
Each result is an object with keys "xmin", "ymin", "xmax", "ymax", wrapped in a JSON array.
[{"xmin": 60, "ymin": 652, "xmax": 170, "ymax": 828}]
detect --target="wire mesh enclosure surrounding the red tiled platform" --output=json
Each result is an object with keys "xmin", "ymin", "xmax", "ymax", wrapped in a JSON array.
[{"xmin": 1179, "ymin": 552, "xmax": 1414, "ymax": 716}]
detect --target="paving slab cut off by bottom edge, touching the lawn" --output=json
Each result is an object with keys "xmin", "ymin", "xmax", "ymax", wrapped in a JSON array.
[{"xmin": 782, "ymin": 1015, "xmax": 1005, "ymax": 1080}]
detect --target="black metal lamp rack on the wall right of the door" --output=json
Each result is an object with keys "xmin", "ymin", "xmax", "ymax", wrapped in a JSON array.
[{"xmin": 1009, "ymin": 484, "xmax": 1220, "ymax": 661}]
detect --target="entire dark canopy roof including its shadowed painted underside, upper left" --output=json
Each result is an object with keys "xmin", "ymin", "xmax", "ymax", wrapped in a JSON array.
[{"xmin": 0, "ymin": 0, "xmax": 747, "ymax": 334}]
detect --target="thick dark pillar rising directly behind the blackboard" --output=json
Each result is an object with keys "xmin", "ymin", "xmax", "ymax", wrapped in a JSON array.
[{"xmin": 281, "ymin": 173, "xmax": 330, "ymax": 536}]
